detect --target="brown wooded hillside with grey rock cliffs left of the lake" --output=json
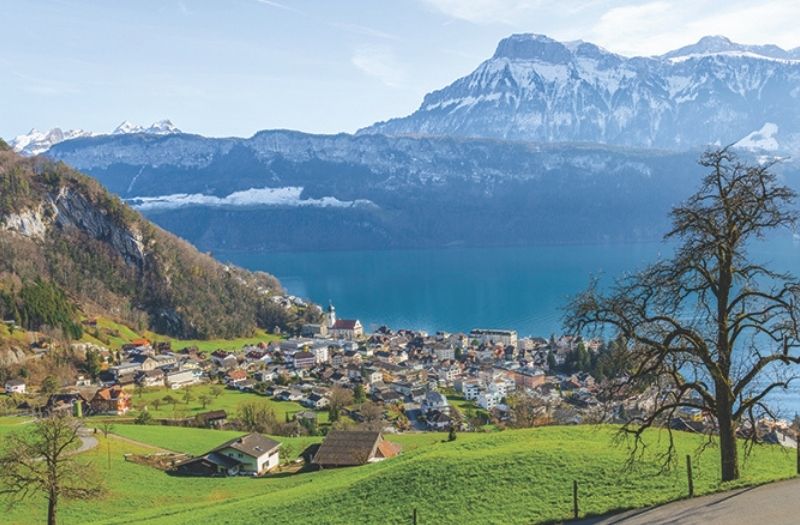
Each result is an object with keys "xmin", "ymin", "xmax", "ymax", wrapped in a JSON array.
[{"xmin": 0, "ymin": 143, "xmax": 314, "ymax": 339}]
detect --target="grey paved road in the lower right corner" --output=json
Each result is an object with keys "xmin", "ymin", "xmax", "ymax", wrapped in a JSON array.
[{"xmin": 571, "ymin": 479, "xmax": 800, "ymax": 525}]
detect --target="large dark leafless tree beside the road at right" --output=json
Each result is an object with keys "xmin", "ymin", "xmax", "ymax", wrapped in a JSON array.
[{"xmin": 566, "ymin": 148, "xmax": 800, "ymax": 481}]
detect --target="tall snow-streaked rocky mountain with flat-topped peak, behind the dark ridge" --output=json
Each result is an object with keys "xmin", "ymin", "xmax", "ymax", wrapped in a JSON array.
[{"xmin": 359, "ymin": 34, "xmax": 800, "ymax": 151}]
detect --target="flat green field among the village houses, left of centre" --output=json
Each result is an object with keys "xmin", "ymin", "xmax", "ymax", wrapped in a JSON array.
[{"xmin": 118, "ymin": 384, "xmax": 328, "ymax": 423}]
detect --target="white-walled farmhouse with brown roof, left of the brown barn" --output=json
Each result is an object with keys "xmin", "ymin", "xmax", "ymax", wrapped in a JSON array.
[{"xmin": 175, "ymin": 433, "xmax": 281, "ymax": 476}]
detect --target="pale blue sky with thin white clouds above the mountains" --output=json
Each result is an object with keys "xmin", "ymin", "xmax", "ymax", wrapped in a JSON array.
[{"xmin": 0, "ymin": 0, "xmax": 800, "ymax": 138}]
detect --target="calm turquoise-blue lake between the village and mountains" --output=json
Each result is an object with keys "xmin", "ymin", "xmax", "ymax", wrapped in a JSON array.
[{"xmin": 215, "ymin": 237, "xmax": 800, "ymax": 337}]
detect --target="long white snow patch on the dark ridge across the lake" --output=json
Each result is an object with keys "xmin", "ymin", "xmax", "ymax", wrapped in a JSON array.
[{"xmin": 128, "ymin": 186, "xmax": 375, "ymax": 210}]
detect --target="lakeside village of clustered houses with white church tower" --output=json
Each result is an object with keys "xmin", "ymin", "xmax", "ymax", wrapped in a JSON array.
[{"xmin": 3, "ymin": 298, "xmax": 794, "ymax": 476}]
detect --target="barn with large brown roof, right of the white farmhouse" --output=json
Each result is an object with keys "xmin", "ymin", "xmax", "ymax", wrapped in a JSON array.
[{"xmin": 312, "ymin": 430, "xmax": 400, "ymax": 468}]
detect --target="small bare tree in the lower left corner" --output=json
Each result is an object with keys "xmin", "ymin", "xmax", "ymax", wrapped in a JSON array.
[{"xmin": 0, "ymin": 415, "xmax": 102, "ymax": 525}]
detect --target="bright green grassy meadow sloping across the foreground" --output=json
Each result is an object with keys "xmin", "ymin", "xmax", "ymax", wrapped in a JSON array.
[{"xmin": 4, "ymin": 425, "xmax": 795, "ymax": 524}]
